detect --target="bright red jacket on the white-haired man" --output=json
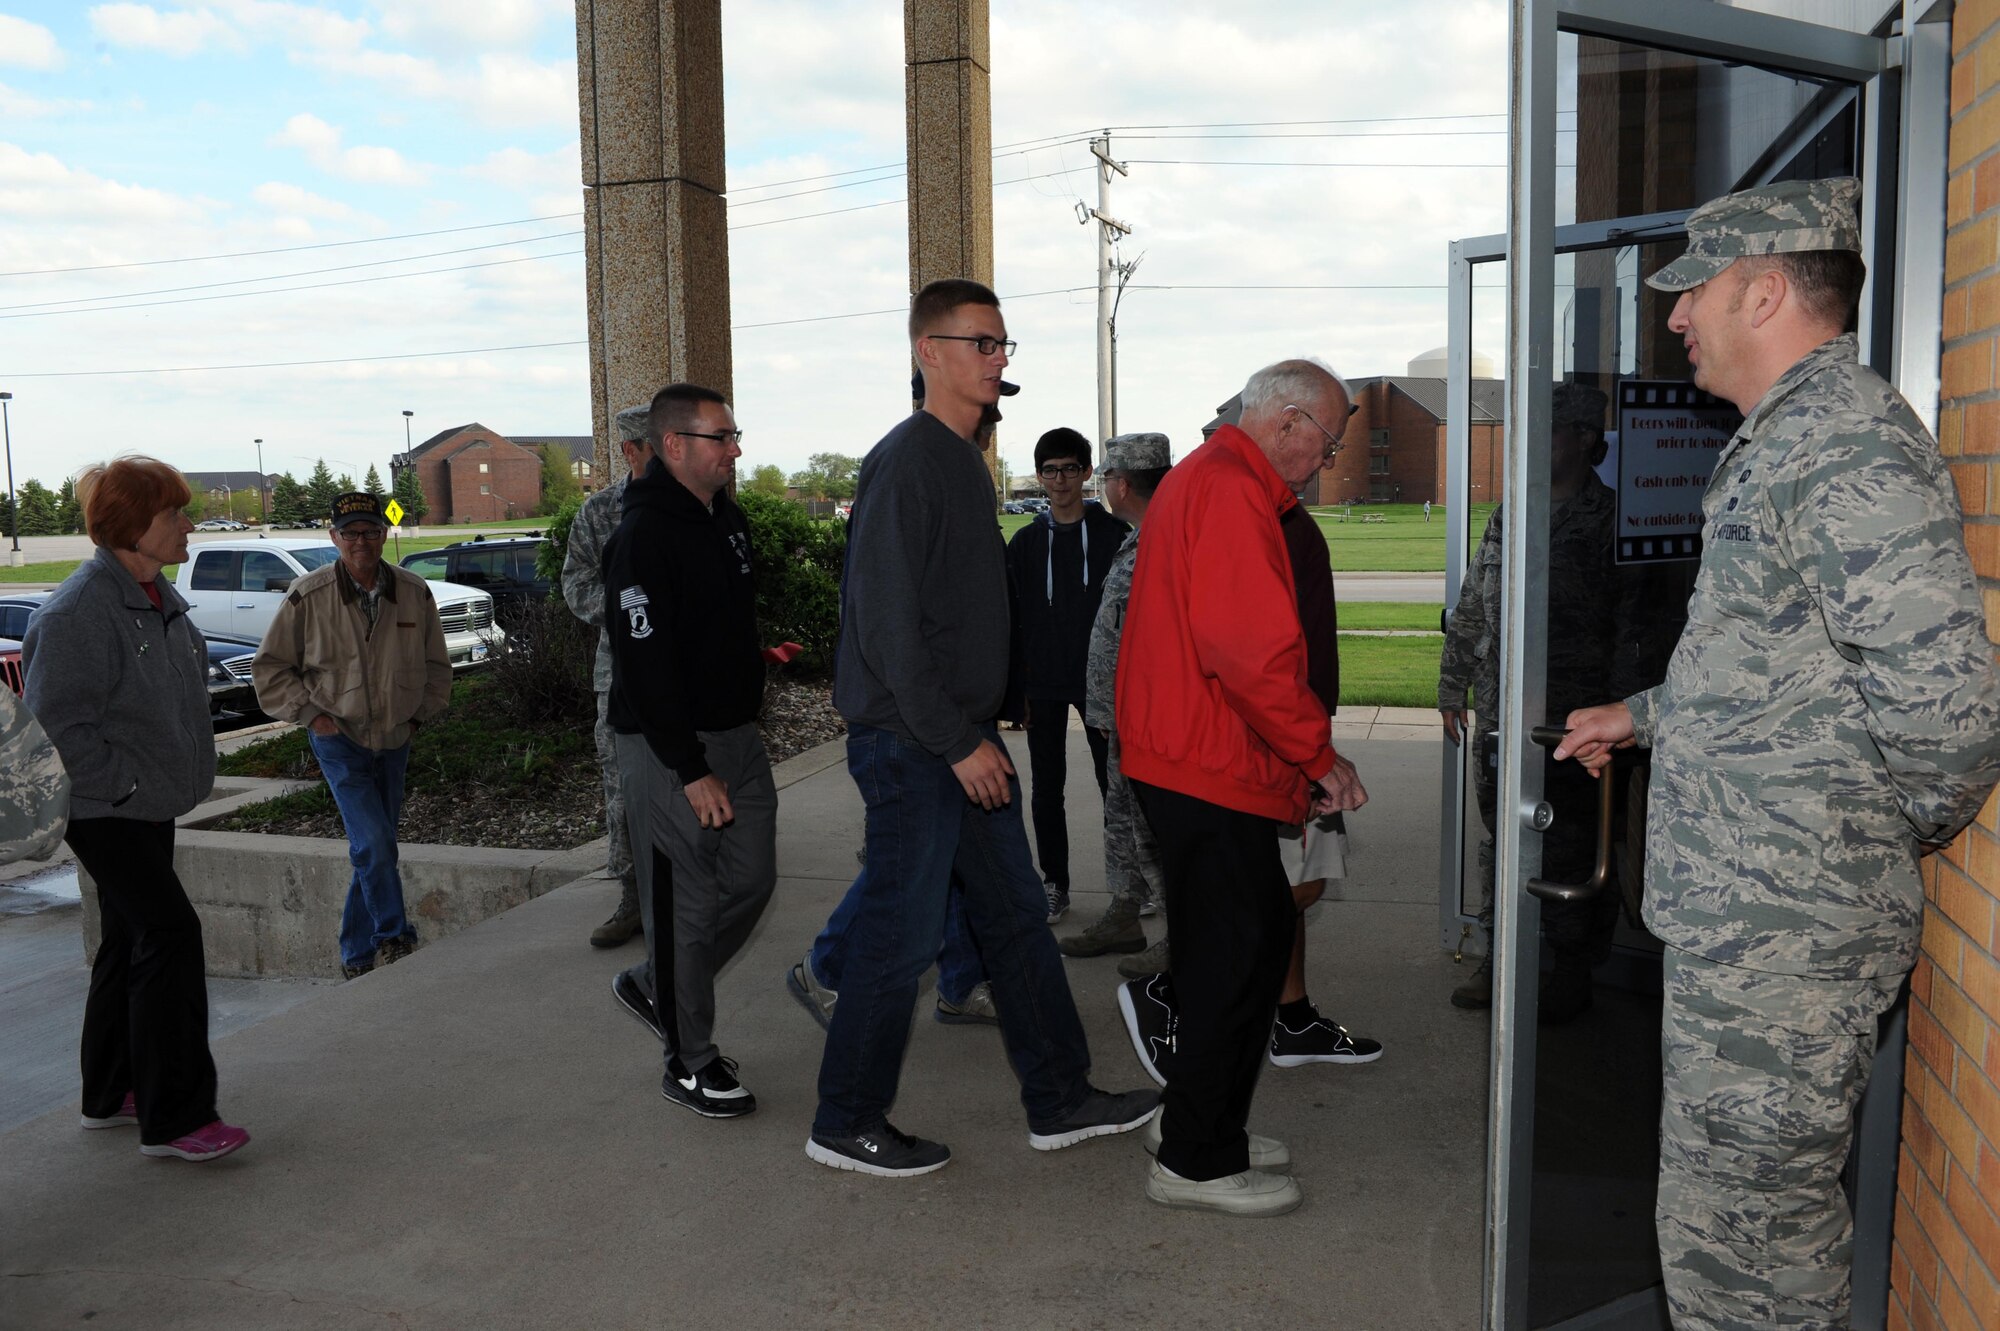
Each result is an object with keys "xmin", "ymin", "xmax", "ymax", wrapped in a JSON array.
[{"xmin": 1116, "ymin": 426, "xmax": 1334, "ymax": 823}]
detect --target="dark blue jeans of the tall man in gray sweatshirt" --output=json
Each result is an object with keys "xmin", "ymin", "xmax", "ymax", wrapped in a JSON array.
[{"xmin": 812, "ymin": 725, "xmax": 1090, "ymax": 1137}]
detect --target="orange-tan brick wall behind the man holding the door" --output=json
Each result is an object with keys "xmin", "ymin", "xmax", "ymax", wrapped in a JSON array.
[{"xmin": 1890, "ymin": 10, "xmax": 2000, "ymax": 1331}]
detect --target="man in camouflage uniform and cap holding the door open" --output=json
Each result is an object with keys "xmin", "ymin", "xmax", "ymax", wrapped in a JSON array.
[{"xmin": 1556, "ymin": 180, "xmax": 2000, "ymax": 1329}]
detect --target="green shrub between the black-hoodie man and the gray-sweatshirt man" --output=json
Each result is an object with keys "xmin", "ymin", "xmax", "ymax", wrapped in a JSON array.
[{"xmin": 736, "ymin": 490, "xmax": 848, "ymax": 675}]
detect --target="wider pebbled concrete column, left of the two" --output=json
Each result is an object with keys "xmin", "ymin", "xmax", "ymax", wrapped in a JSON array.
[{"xmin": 576, "ymin": 0, "xmax": 734, "ymax": 478}]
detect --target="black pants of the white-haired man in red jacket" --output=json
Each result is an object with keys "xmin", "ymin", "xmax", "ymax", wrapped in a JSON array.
[{"xmin": 1132, "ymin": 781, "xmax": 1298, "ymax": 1179}]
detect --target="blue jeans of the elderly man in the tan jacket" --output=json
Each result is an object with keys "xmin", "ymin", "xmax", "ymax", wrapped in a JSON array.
[{"xmin": 306, "ymin": 729, "xmax": 410, "ymax": 965}]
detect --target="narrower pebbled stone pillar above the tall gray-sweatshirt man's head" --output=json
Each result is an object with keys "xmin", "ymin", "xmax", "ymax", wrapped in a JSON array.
[{"xmin": 902, "ymin": 0, "xmax": 1000, "ymax": 477}]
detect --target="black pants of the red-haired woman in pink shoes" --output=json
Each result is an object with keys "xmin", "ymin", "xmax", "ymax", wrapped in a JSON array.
[{"xmin": 66, "ymin": 817, "xmax": 216, "ymax": 1145}]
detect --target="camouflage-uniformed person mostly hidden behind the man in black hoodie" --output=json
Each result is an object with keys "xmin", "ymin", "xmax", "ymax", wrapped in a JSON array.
[{"xmin": 562, "ymin": 404, "xmax": 660, "ymax": 955}]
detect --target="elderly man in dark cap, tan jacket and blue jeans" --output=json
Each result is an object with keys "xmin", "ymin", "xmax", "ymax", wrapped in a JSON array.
[{"xmin": 250, "ymin": 492, "xmax": 452, "ymax": 979}]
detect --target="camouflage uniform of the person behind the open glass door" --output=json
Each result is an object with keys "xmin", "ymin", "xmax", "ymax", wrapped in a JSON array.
[{"xmin": 1438, "ymin": 465, "xmax": 1632, "ymax": 943}]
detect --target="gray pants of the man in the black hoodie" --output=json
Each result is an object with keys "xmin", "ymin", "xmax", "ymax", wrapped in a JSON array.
[{"xmin": 618, "ymin": 725, "xmax": 778, "ymax": 1073}]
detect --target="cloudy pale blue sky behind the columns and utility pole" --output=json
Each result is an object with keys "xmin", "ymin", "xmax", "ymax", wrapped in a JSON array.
[{"xmin": 0, "ymin": 0, "xmax": 1506, "ymax": 486}]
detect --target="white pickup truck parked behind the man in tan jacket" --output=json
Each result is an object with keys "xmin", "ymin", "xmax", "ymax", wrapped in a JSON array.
[{"xmin": 174, "ymin": 536, "xmax": 506, "ymax": 677}]
